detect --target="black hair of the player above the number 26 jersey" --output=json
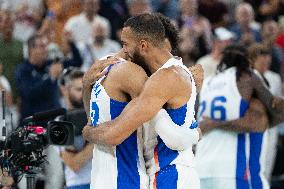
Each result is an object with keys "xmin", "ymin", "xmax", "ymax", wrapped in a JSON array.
[{"xmin": 218, "ymin": 44, "xmax": 251, "ymax": 81}]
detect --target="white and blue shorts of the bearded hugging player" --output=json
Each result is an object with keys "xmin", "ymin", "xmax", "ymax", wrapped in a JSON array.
[{"xmin": 150, "ymin": 165, "xmax": 200, "ymax": 189}]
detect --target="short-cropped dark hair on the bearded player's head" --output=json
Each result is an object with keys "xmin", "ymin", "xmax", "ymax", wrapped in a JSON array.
[{"xmin": 124, "ymin": 13, "xmax": 165, "ymax": 46}]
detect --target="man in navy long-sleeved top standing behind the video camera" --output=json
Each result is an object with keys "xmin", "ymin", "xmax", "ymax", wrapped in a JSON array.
[{"xmin": 15, "ymin": 35, "xmax": 62, "ymax": 120}]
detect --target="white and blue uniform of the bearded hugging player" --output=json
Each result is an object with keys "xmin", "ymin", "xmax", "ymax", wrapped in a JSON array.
[{"xmin": 145, "ymin": 58, "xmax": 199, "ymax": 189}]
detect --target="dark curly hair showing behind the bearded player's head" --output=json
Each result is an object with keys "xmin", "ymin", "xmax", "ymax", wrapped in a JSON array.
[{"xmin": 154, "ymin": 13, "xmax": 179, "ymax": 54}]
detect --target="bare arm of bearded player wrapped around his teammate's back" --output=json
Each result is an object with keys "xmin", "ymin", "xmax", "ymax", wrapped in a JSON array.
[{"xmin": 83, "ymin": 68, "xmax": 191, "ymax": 145}]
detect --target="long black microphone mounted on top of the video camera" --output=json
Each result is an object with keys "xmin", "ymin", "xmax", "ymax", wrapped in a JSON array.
[{"xmin": 23, "ymin": 108, "xmax": 66, "ymax": 123}]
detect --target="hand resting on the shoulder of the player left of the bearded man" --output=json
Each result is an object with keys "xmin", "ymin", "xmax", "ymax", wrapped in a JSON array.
[{"xmin": 83, "ymin": 57, "xmax": 119, "ymax": 86}]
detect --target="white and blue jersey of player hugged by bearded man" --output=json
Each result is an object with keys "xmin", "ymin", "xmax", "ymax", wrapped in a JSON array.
[{"xmin": 90, "ymin": 61, "xmax": 149, "ymax": 189}]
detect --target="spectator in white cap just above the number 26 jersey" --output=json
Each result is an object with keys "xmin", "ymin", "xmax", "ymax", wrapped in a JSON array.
[{"xmin": 197, "ymin": 28, "xmax": 234, "ymax": 79}]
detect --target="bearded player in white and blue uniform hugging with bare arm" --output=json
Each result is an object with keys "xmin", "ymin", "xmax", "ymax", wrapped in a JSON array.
[{"xmin": 83, "ymin": 14, "xmax": 199, "ymax": 188}]
